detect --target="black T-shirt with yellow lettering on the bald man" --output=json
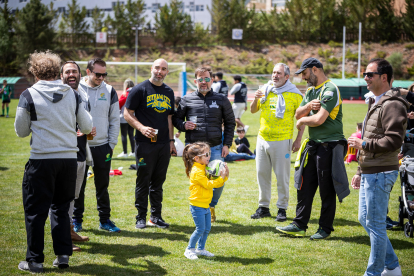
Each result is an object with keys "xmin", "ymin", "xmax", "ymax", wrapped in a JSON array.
[{"xmin": 125, "ymin": 80, "xmax": 174, "ymax": 143}]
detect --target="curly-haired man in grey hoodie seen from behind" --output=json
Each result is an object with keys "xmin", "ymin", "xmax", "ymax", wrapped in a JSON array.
[{"xmin": 14, "ymin": 51, "xmax": 92, "ymax": 273}]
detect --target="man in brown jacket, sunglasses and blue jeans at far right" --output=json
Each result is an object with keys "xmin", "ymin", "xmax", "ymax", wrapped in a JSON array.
[{"xmin": 348, "ymin": 59, "xmax": 409, "ymax": 276}]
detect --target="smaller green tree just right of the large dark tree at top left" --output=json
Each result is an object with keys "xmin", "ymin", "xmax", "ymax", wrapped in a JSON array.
[{"xmin": 59, "ymin": 0, "xmax": 89, "ymax": 46}]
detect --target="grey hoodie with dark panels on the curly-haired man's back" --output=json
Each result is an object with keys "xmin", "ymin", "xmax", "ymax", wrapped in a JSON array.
[{"xmin": 14, "ymin": 80, "xmax": 92, "ymax": 159}]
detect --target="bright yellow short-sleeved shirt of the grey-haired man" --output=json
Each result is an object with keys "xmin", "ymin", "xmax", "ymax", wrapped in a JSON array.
[{"xmin": 257, "ymin": 92, "xmax": 302, "ymax": 141}]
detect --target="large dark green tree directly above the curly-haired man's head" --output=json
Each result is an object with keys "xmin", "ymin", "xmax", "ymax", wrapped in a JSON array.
[{"xmin": 13, "ymin": 0, "xmax": 56, "ymax": 68}]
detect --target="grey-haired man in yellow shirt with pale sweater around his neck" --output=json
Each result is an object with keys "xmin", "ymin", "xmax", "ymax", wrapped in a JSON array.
[{"xmin": 250, "ymin": 63, "xmax": 305, "ymax": 221}]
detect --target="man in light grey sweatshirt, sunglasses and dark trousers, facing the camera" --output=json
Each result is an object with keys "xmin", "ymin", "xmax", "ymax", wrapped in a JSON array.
[{"xmin": 73, "ymin": 58, "xmax": 121, "ymax": 232}]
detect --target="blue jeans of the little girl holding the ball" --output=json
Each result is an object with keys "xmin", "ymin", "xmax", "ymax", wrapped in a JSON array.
[{"xmin": 187, "ymin": 205, "xmax": 211, "ymax": 250}]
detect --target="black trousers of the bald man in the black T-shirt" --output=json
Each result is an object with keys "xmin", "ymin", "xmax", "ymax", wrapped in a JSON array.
[{"xmin": 135, "ymin": 142, "xmax": 171, "ymax": 220}]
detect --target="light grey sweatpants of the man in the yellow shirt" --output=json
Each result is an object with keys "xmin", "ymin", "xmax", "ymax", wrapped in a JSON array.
[{"xmin": 256, "ymin": 136, "xmax": 292, "ymax": 210}]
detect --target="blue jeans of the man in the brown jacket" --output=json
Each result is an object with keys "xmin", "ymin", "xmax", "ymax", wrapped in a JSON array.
[{"xmin": 358, "ymin": 171, "xmax": 399, "ymax": 276}]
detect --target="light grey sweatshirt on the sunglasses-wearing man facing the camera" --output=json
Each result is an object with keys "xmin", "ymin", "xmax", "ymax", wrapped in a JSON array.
[{"xmin": 78, "ymin": 77, "xmax": 120, "ymax": 149}]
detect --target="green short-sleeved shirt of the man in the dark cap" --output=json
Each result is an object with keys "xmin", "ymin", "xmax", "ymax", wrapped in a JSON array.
[{"xmin": 300, "ymin": 80, "xmax": 345, "ymax": 143}]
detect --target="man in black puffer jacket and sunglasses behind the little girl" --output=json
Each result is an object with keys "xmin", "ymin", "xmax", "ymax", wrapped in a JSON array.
[{"xmin": 173, "ymin": 67, "xmax": 236, "ymax": 222}]
